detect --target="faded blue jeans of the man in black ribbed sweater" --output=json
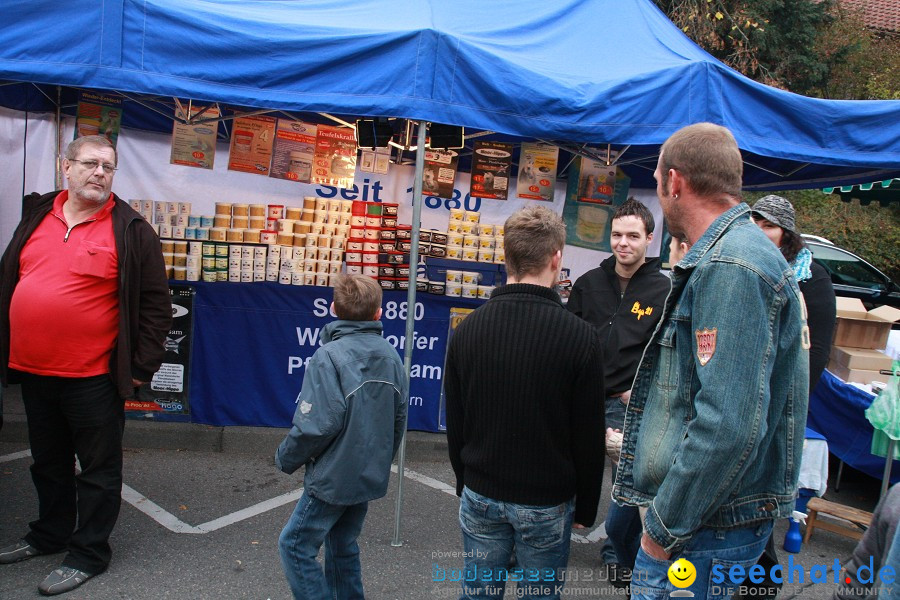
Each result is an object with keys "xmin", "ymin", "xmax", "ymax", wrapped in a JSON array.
[{"xmin": 459, "ymin": 488, "xmax": 575, "ymax": 600}]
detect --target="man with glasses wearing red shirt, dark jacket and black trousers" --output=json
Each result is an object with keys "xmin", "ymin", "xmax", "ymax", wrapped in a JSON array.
[{"xmin": 0, "ymin": 136, "xmax": 172, "ymax": 595}]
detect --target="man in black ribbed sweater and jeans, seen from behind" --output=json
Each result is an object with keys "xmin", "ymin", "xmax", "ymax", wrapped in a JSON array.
[{"xmin": 444, "ymin": 206, "xmax": 604, "ymax": 598}]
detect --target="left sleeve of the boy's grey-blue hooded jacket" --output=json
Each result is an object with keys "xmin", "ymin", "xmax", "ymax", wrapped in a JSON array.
[{"xmin": 275, "ymin": 348, "xmax": 347, "ymax": 473}]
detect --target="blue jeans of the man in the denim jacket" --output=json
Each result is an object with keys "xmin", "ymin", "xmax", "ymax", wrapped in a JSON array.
[{"xmin": 631, "ymin": 521, "xmax": 774, "ymax": 600}]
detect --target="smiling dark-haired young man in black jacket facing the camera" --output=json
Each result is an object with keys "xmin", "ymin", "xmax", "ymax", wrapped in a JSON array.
[{"xmin": 568, "ymin": 198, "xmax": 671, "ymax": 587}]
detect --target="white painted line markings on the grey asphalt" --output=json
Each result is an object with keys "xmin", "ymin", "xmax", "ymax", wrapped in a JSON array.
[{"xmin": 0, "ymin": 450, "xmax": 606, "ymax": 544}]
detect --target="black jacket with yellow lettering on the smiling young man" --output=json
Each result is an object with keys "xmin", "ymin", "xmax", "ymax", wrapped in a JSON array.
[{"xmin": 567, "ymin": 256, "xmax": 672, "ymax": 396}]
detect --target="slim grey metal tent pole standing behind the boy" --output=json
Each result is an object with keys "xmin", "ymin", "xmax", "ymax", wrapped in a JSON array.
[{"xmin": 391, "ymin": 121, "xmax": 426, "ymax": 547}]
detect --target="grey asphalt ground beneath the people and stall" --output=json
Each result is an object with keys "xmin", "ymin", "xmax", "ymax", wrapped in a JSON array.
[{"xmin": 0, "ymin": 387, "xmax": 878, "ymax": 600}]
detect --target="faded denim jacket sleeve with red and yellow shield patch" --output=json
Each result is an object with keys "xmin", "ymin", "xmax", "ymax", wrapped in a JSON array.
[{"xmin": 645, "ymin": 258, "xmax": 786, "ymax": 552}]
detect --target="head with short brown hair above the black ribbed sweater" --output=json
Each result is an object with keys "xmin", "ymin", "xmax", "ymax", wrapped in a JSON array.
[{"xmin": 503, "ymin": 204, "xmax": 566, "ymax": 279}]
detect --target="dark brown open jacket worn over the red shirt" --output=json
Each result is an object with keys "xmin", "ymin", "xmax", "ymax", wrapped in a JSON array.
[{"xmin": 0, "ymin": 191, "xmax": 172, "ymax": 398}]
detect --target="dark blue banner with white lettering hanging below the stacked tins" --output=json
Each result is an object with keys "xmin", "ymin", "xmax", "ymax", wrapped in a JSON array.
[{"xmin": 191, "ymin": 282, "xmax": 483, "ymax": 431}]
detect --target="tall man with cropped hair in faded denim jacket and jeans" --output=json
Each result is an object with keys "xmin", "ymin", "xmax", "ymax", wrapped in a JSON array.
[{"xmin": 613, "ymin": 123, "xmax": 809, "ymax": 598}]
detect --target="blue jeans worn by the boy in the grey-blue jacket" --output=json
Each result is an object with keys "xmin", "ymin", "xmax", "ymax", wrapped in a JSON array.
[{"xmin": 278, "ymin": 493, "xmax": 369, "ymax": 600}]
